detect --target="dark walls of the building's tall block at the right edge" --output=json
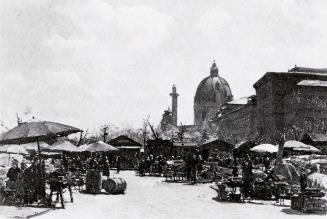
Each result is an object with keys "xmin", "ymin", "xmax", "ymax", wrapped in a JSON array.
[{"xmin": 254, "ymin": 72, "xmax": 327, "ymax": 143}]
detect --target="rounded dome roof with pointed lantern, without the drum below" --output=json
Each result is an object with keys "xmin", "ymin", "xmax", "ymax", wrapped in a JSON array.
[{"xmin": 194, "ymin": 62, "xmax": 233, "ymax": 106}]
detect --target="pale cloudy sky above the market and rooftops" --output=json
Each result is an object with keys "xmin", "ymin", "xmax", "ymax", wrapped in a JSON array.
[{"xmin": 0, "ymin": 0, "xmax": 327, "ymax": 132}]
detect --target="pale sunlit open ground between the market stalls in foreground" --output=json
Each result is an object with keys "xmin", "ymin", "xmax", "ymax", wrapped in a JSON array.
[{"xmin": 1, "ymin": 171, "xmax": 326, "ymax": 219}]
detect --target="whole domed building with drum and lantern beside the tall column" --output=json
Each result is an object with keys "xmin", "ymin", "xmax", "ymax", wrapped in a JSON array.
[{"xmin": 194, "ymin": 62, "xmax": 233, "ymax": 129}]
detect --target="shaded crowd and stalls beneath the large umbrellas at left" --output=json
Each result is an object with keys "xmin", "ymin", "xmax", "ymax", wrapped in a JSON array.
[{"xmin": 0, "ymin": 153, "xmax": 121, "ymax": 207}]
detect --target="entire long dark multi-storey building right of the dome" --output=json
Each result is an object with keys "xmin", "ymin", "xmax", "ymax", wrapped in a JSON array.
[{"xmin": 212, "ymin": 67, "xmax": 327, "ymax": 151}]
